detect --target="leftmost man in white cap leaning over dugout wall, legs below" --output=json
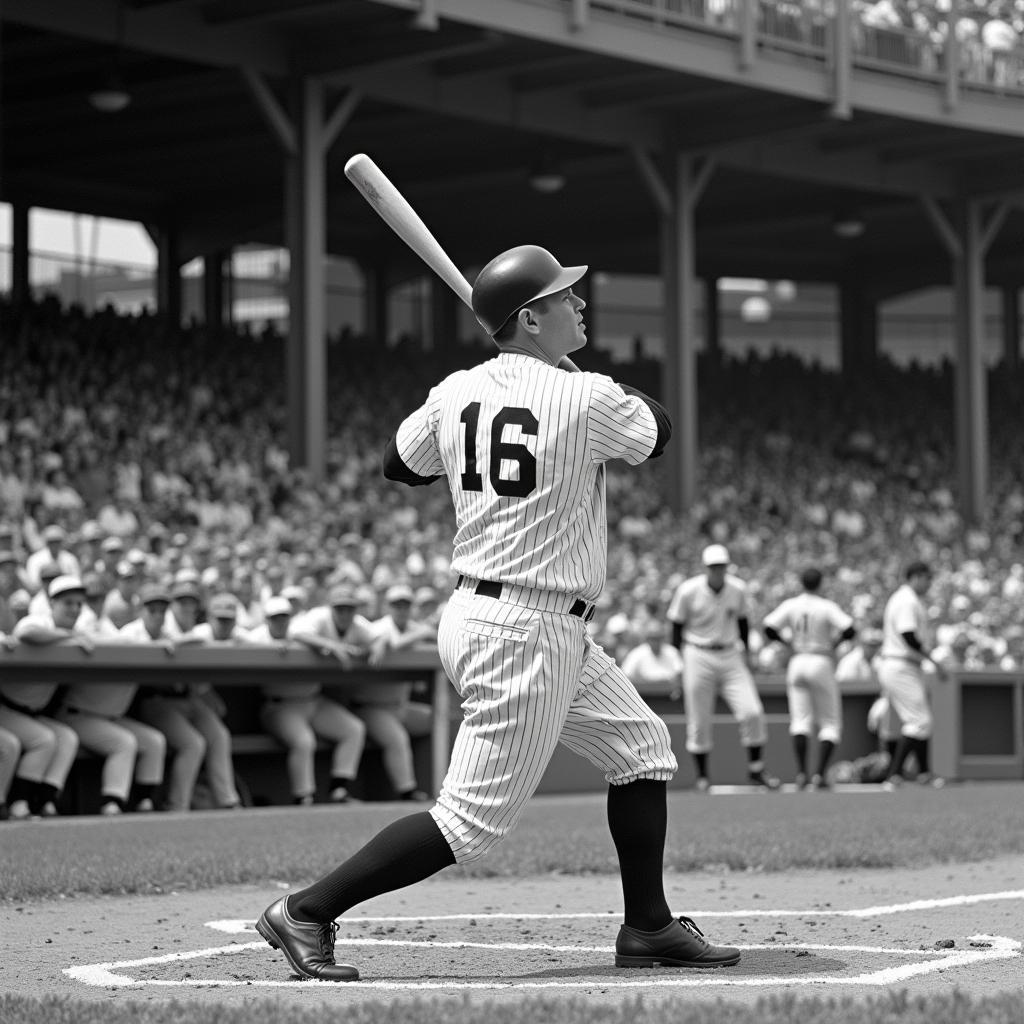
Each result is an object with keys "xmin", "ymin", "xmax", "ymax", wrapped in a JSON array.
[{"xmin": 0, "ymin": 577, "xmax": 87, "ymax": 818}]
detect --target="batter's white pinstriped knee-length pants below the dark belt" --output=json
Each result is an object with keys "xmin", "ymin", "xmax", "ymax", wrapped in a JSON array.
[{"xmin": 430, "ymin": 590, "xmax": 677, "ymax": 863}]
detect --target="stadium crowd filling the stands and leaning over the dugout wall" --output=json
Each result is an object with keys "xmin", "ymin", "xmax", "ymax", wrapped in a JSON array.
[{"xmin": 0, "ymin": 299, "xmax": 1024, "ymax": 813}]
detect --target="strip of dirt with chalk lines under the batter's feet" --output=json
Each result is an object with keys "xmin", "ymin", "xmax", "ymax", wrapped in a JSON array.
[{"xmin": 0, "ymin": 857, "xmax": 1024, "ymax": 1005}]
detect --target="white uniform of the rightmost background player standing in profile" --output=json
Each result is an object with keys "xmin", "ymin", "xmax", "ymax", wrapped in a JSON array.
[{"xmin": 879, "ymin": 584, "xmax": 932, "ymax": 739}]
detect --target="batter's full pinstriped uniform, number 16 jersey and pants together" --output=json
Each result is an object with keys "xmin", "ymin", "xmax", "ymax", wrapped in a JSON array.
[{"xmin": 393, "ymin": 352, "xmax": 676, "ymax": 862}]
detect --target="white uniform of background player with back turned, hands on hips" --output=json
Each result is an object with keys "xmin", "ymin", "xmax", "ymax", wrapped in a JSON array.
[{"xmin": 764, "ymin": 593, "xmax": 853, "ymax": 743}]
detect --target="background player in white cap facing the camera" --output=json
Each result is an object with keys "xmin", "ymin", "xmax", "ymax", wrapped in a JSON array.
[{"xmin": 668, "ymin": 544, "xmax": 779, "ymax": 792}]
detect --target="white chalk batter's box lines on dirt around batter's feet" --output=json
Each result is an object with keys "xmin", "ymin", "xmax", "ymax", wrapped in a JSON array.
[{"xmin": 63, "ymin": 889, "xmax": 1024, "ymax": 991}]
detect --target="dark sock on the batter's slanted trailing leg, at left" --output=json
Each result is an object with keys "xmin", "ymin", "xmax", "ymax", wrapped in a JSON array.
[{"xmin": 288, "ymin": 811, "xmax": 455, "ymax": 922}]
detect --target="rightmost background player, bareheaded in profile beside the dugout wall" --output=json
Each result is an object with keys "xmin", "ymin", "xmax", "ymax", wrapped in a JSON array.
[{"xmin": 879, "ymin": 561, "xmax": 946, "ymax": 788}]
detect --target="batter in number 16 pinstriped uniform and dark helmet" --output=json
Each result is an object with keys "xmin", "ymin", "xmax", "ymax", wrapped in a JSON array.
[{"xmin": 256, "ymin": 246, "xmax": 739, "ymax": 981}]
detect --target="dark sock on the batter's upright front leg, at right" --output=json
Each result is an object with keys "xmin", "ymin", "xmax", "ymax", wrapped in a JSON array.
[{"xmin": 608, "ymin": 778, "xmax": 672, "ymax": 932}]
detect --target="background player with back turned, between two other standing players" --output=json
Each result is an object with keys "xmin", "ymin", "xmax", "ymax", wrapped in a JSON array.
[{"xmin": 764, "ymin": 566, "xmax": 857, "ymax": 790}]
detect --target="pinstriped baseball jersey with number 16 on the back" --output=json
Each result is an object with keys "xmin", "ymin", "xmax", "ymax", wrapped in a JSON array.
[{"xmin": 396, "ymin": 352, "xmax": 657, "ymax": 601}]
